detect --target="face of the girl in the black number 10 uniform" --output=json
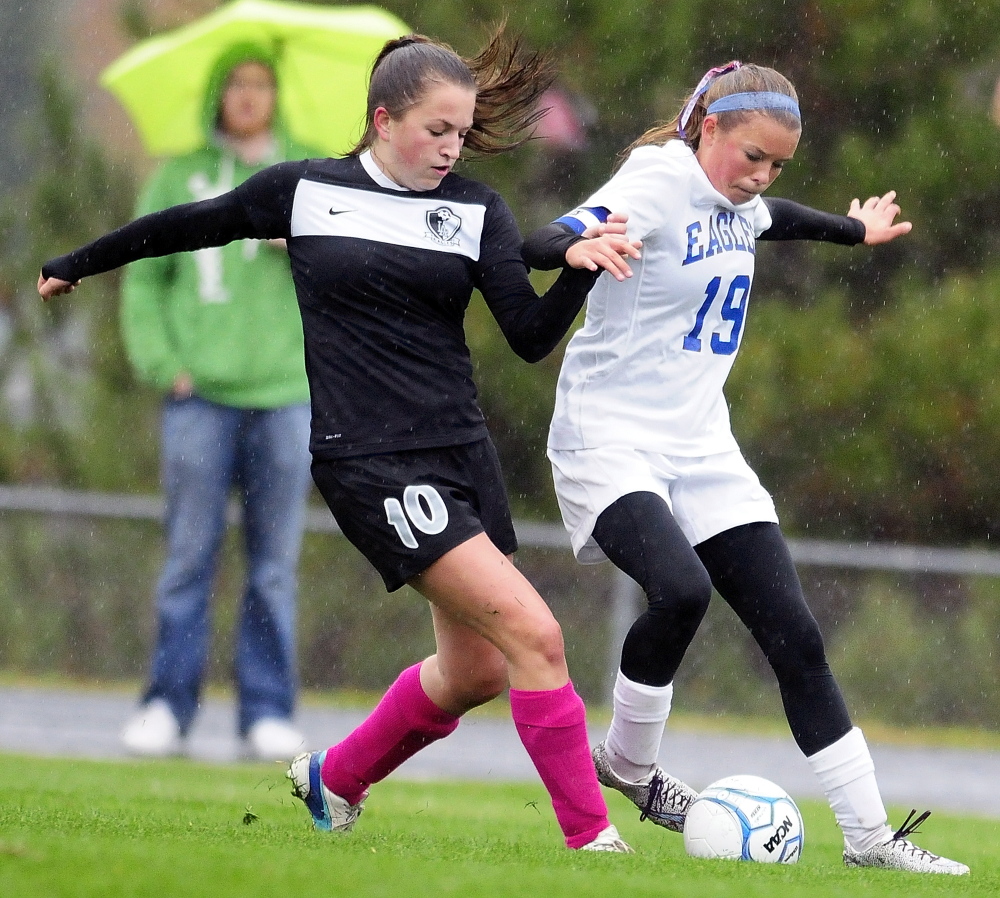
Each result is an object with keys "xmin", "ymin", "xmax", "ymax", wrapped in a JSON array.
[{"xmin": 372, "ymin": 81, "xmax": 476, "ymax": 190}]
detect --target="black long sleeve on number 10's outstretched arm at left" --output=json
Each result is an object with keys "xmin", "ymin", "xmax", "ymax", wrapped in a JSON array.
[{"xmin": 42, "ymin": 191, "xmax": 262, "ymax": 283}]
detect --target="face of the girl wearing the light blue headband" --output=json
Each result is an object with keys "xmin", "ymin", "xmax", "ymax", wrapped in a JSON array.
[{"xmin": 695, "ymin": 113, "xmax": 802, "ymax": 206}]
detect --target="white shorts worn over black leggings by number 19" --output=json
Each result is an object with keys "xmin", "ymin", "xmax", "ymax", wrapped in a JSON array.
[{"xmin": 548, "ymin": 446, "xmax": 778, "ymax": 564}]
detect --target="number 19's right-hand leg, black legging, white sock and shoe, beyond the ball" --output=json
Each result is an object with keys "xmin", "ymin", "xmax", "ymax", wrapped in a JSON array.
[{"xmin": 696, "ymin": 522, "xmax": 968, "ymax": 873}]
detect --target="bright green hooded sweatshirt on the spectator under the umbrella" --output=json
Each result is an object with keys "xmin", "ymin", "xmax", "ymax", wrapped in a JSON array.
[{"xmin": 121, "ymin": 47, "xmax": 310, "ymax": 409}]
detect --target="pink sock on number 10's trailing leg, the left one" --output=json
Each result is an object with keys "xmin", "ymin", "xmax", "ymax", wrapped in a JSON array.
[{"xmin": 320, "ymin": 664, "xmax": 459, "ymax": 804}]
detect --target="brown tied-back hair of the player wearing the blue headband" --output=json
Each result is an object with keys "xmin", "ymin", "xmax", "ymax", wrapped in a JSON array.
[{"xmin": 619, "ymin": 63, "xmax": 802, "ymax": 164}]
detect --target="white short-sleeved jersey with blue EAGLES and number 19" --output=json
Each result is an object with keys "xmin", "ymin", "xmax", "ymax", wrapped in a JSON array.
[{"xmin": 548, "ymin": 140, "xmax": 771, "ymax": 457}]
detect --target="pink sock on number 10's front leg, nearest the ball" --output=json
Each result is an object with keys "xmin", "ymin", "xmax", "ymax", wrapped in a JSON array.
[{"xmin": 510, "ymin": 683, "xmax": 608, "ymax": 848}]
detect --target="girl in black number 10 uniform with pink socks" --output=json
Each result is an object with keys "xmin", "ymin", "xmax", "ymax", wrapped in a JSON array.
[{"xmin": 38, "ymin": 33, "xmax": 638, "ymax": 852}]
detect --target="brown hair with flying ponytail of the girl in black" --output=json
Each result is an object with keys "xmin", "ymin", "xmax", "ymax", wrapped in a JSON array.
[{"xmin": 348, "ymin": 25, "xmax": 555, "ymax": 156}]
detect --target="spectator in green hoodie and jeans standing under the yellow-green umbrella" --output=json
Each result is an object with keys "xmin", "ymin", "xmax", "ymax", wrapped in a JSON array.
[{"xmin": 116, "ymin": 47, "xmax": 310, "ymax": 760}]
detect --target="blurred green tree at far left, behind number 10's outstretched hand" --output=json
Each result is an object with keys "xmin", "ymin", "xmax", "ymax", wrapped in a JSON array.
[{"xmin": 0, "ymin": 65, "xmax": 156, "ymax": 489}]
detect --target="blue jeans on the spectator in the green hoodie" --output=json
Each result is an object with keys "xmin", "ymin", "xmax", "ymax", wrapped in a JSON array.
[{"xmin": 143, "ymin": 397, "xmax": 311, "ymax": 736}]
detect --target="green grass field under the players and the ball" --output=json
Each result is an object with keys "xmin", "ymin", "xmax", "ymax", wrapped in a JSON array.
[{"xmin": 0, "ymin": 755, "xmax": 1000, "ymax": 898}]
